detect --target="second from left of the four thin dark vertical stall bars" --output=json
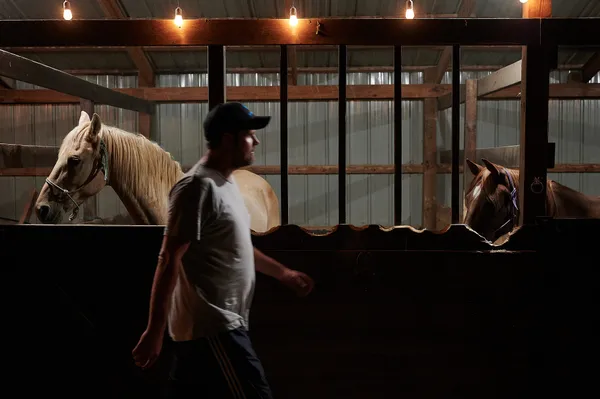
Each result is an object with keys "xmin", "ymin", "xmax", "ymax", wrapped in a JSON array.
[{"xmin": 338, "ymin": 44, "xmax": 346, "ymax": 224}]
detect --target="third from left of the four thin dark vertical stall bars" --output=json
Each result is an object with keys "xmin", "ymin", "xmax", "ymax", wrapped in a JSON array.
[{"xmin": 394, "ymin": 46, "xmax": 402, "ymax": 226}]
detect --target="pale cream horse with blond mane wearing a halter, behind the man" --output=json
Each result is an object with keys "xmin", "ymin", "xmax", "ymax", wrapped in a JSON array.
[{"xmin": 35, "ymin": 111, "xmax": 280, "ymax": 233}]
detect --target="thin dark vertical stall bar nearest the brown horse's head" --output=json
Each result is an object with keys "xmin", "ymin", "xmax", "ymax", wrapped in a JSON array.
[{"xmin": 451, "ymin": 44, "xmax": 460, "ymax": 224}]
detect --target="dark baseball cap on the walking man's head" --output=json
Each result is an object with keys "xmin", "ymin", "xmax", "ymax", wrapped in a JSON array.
[{"xmin": 204, "ymin": 102, "xmax": 271, "ymax": 141}]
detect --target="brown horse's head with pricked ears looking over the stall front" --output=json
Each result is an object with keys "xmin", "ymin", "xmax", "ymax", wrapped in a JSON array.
[{"xmin": 464, "ymin": 159, "xmax": 519, "ymax": 241}]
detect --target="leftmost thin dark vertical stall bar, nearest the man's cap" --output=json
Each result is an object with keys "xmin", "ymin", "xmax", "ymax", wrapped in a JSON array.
[{"xmin": 279, "ymin": 45, "xmax": 289, "ymax": 225}]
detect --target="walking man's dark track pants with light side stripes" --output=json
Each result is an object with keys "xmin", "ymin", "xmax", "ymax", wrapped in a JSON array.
[{"xmin": 169, "ymin": 328, "xmax": 272, "ymax": 399}]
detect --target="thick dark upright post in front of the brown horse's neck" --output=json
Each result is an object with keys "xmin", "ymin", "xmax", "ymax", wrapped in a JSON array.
[{"xmin": 519, "ymin": 0, "xmax": 552, "ymax": 225}]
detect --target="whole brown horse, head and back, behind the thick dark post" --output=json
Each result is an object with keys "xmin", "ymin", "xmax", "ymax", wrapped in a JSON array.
[{"xmin": 464, "ymin": 159, "xmax": 600, "ymax": 241}]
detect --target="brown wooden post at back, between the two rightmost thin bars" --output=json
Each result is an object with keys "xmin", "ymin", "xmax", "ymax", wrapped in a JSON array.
[{"xmin": 423, "ymin": 68, "xmax": 438, "ymax": 230}]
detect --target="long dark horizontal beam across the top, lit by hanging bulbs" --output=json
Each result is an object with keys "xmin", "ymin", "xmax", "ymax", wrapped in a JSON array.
[{"xmin": 0, "ymin": 17, "xmax": 541, "ymax": 47}]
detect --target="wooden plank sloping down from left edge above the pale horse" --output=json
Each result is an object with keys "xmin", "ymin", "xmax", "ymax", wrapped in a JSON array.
[{"xmin": 0, "ymin": 49, "xmax": 154, "ymax": 114}]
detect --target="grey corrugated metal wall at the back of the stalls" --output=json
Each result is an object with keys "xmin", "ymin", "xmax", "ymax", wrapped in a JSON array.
[{"xmin": 0, "ymin": 72, "xmax": 600, "ymax": 226}]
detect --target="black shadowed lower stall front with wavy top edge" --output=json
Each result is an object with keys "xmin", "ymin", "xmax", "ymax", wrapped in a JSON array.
[{"xmin": 0, "ymin": 221, "xmax": 600, "ymax": 399}]
